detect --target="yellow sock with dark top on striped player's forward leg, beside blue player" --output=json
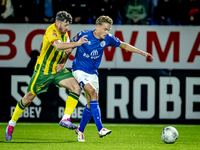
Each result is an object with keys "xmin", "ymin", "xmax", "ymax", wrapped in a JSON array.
[{"xmin": 64, "ymin": 92, "xmax": 79, "ymax": 116}]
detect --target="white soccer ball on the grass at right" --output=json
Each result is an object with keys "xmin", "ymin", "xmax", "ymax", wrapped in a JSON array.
[{"xmin": 161, "ymin": 126, "xmax": 178, "ymax": 144}]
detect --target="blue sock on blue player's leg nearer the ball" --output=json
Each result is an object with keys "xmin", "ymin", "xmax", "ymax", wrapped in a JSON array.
[{"xmin": 90, "ymin": 101, "xmax": 103, "ymax": 131}]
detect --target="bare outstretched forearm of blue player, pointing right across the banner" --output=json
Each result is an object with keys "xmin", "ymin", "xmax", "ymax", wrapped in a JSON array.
[{"xmin": 119, "ymin": 42, "xmax": 154, "ymax": 60}]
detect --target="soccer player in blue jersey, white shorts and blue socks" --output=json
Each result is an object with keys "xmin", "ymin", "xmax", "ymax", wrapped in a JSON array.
[{"xmin": 71, "ymin": 16, "xmax": 153, "ymax": 142}]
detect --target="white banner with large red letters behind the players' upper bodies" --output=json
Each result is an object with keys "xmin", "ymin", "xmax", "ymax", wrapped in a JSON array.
[{"xmin": 0, "ymin": 24, "xmax": 200, "ymax": 69}]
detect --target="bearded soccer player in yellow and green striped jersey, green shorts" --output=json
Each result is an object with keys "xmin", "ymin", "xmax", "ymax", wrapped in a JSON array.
[{"xmin": 5, "ymin": 11, "xmax": 87, "ymax": 141}]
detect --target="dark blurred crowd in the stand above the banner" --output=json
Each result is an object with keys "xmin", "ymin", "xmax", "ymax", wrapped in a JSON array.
[{"xmin": 0, "ymin": 0, "xmax": 200, "ymax": 25}]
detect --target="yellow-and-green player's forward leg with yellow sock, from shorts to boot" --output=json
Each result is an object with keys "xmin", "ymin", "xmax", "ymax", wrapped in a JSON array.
[{"xmin": 55, "ymin": 69, "xmax": 81, "ymax": 129}]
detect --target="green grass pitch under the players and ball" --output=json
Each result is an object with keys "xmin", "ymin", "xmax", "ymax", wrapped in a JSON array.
[{"xmin": 0, "ymin": 122, "xmax": 200, "ymax": 150}]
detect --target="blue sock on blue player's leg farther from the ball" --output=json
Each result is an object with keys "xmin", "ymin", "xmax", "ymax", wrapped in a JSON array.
[{"xmin": 79, "ymin": 104, "xmax": 92, "ymax": 132}]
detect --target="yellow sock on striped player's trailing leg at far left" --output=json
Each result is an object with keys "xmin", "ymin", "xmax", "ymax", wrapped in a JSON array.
[{"xmin": 11, "ymin": 100, "xmax": 26, "ymax": 122}]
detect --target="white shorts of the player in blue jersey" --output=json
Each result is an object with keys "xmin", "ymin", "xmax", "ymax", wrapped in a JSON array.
[{"xmin": 72, "ymin": 70, "xmax": 99, "ymax": 93}]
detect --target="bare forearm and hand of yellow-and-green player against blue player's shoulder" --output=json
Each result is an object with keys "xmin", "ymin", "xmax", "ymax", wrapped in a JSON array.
[{"xmin": 52, "ymin": 36, "xmax": 88, "ymax": 50}]
